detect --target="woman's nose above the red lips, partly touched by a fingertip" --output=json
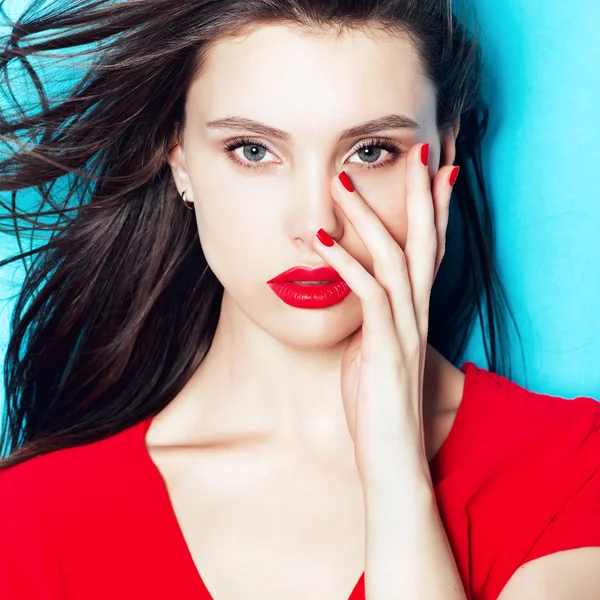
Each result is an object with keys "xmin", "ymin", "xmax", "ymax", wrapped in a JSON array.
[{"xmin": 285, "ymin": 171, "xmax": 344, "ymax": 247}]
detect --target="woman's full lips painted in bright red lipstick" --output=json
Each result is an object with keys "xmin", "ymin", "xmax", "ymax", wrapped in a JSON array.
[{"xmin": 267, "ymin": 267, "xmax": 352, "ymax": 308}]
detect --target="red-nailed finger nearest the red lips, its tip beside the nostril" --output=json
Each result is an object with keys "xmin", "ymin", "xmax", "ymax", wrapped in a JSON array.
[{"xmin": 314, "ymin": 229, "xmax": 400, "ymax": 364}]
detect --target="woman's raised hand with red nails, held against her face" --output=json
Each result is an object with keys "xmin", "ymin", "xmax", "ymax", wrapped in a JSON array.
[{"xmin": 314, "ymin": 143, "xmax": 457, "ymax": 486}]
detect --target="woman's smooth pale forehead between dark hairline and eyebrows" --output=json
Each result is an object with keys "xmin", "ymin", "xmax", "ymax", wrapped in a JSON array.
[{"xmin": 188, "ymin": 25, "xmax": 435, "ymax": 131}]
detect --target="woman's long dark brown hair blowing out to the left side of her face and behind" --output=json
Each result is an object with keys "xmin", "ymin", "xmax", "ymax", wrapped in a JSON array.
[{"xmin": 0, "ymin": 0, "xmax": 516, "ymax": 468}]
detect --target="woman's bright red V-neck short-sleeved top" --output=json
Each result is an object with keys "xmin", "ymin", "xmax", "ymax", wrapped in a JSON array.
[{"xmin": 0, "ymin": 363, "xmax": 600, "ymax": 600}]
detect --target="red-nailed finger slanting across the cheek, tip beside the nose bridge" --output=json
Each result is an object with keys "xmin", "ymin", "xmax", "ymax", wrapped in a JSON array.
[{"xmin": 332, "ymin": 172, "xmax": 419, "ymax": 356}]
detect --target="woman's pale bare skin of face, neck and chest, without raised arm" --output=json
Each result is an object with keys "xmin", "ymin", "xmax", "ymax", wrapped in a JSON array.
[{"xmin": 154, "ymin": 25, "xmax": 464, "ymax": 598}]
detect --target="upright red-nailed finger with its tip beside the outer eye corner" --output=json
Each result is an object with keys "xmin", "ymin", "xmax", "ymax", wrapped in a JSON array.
[{"xmin": 404, "ymin": 144, "xmax": 437, "ymax": 340}]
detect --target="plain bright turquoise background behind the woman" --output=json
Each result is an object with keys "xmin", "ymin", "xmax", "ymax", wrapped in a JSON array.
[{"xmin": 0, "ymin": 0, "xmax": 600, "ymax": 428}]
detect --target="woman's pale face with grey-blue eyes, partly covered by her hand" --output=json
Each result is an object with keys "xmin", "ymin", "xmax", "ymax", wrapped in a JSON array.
[{"xmin": 169, "ymin": 25, "xmax": 454, "ymax": 347}]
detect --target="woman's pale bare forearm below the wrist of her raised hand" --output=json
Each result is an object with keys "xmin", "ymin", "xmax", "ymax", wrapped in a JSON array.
[{"xmin": 365, "ymin": 471, "xmax": 467, "ymax": 600}]
